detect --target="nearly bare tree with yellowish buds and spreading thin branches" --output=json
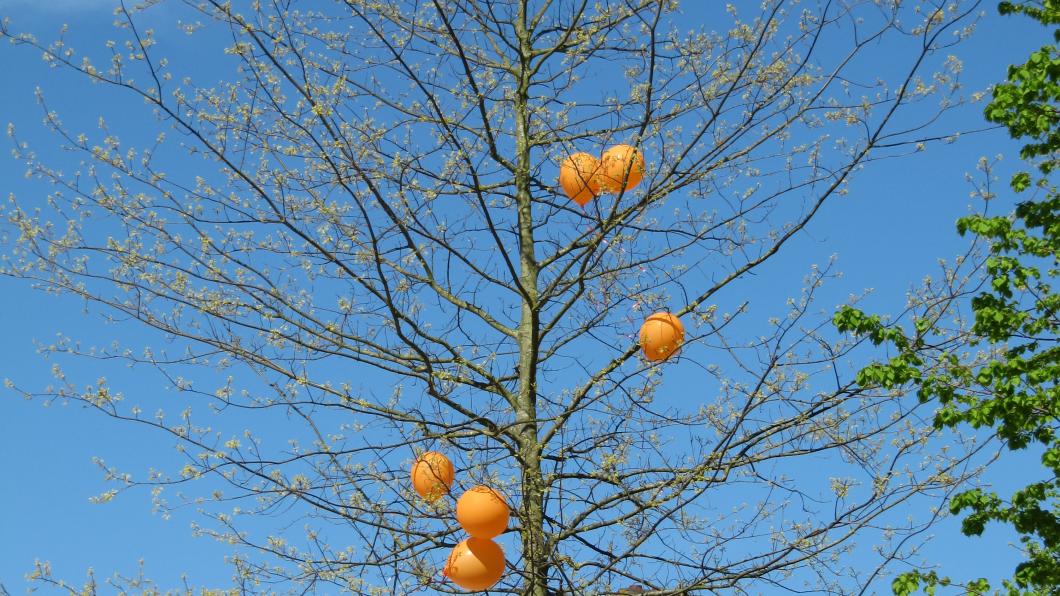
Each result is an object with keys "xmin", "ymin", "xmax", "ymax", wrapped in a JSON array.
[{"xmin": 2, "ymin": 0, "xmax": 982, "ymax": 596}]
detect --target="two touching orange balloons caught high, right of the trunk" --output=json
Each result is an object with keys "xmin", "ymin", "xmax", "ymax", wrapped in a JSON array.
[{"xmin": 560, "ymin": 145, "xmax": 644, "ymax": 207}]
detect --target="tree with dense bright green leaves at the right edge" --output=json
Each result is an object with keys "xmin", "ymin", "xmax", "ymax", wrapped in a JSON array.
[{"xmin": 835, "ymin": 0, "xmax": 1060, "ymax": 594}]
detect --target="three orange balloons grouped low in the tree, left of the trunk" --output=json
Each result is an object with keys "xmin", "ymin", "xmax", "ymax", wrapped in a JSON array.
[{"xmin": 412, "ymin": 451, "xmax": 511, "ymax": 590}]
